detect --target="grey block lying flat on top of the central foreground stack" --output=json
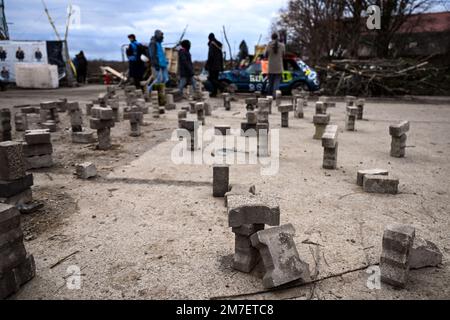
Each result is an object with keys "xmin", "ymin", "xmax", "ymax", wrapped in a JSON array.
[{"xmin": 227, "ymin": 194, "xmax": 280, "ymax": 227}]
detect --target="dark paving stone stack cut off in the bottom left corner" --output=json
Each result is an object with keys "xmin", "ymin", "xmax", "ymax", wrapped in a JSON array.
[{"xmin": 0, "ymin": 203, "xmax": 36, "ymax": 299}]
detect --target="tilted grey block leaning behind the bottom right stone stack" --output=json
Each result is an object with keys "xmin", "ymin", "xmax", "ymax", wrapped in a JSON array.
[{"xmin": 409, "ymin": 237, "xmax": 442, "ymax": 269}]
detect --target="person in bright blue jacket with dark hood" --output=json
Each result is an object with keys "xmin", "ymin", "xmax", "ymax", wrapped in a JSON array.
[{"xmin": 149, "ymin": 30, "xmax": 169, "ymax": 92}]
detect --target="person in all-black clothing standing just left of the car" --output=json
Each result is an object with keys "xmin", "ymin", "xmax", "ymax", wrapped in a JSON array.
[{"xmin": 205, "ymin": 33, "xmax": 223, "ymax": 97}]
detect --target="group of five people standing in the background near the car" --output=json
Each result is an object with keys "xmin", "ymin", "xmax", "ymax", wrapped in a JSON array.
[{"xmin": 126, "ymin": 30, "xmax": 285, "ymax": 97}]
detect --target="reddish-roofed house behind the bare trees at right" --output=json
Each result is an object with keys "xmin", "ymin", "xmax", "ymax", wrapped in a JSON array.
[{"xmin": 358, "ymin": 12, "xmax": 450, "ymax": 58}]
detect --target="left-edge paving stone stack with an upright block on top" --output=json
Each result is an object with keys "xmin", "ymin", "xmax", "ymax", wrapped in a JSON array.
[{"xmin": 0, "ymin": 141, "xmax": 33, "ymax": 206}]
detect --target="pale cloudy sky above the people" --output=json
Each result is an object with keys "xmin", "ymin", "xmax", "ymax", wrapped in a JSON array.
[{"xmin": 5, "ymin": 0, "xmax": 287, "ymax": 60}]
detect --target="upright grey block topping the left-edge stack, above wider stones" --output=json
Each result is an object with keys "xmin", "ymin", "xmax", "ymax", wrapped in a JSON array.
[{"xmin": 0, "ymin": 141, "xmax": 26, "ymax": 181}]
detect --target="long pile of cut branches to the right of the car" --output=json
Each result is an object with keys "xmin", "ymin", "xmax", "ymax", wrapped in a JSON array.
[{"xmin": 316, "ymin": 59, "xmax": 450, "ymax": 97}]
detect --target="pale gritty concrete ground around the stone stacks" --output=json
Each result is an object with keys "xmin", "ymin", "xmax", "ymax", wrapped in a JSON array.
[{"xmin": 0, "ymin": 86, "xmax": 450, "ymax": 299}]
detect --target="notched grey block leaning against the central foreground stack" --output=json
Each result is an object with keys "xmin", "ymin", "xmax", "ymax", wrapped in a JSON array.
[{"xmin": 250, "ymin": 224, "xmax": 311, "ymax": 288}]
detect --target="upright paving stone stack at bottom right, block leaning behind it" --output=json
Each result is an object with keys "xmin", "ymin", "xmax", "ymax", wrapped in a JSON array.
[{"xmin": 380, "ymin": 225, "xmax": 416, "ymax": 288}]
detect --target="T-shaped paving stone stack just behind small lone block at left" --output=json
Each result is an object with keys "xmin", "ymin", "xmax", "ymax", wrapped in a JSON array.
[{"xmin": 89, "ymin": 106, "xmax": 115, "ymax": 150}]
